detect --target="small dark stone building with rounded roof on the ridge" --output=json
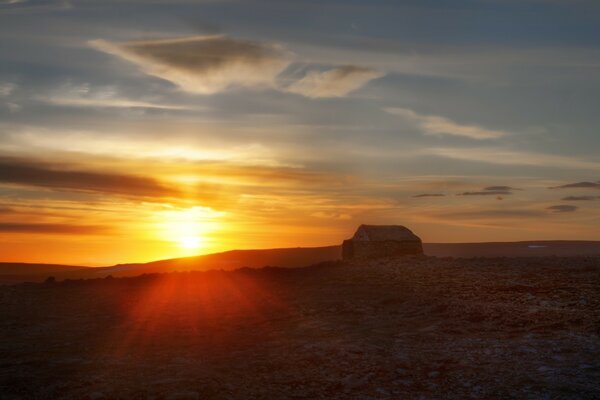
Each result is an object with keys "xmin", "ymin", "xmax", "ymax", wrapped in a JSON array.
[{"xmin": 342, "ymin": 225, "xmax": 423, "ymax": 260}]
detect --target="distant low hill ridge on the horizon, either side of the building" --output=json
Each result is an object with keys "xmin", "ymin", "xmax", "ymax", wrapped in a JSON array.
[{"xmin": 0, "ymin": 240, "xmax": 600, "ymax": 284}]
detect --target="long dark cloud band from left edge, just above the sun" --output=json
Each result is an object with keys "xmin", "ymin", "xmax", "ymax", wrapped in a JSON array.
[{"xmin": 0, "ymin": 158, "xmax": 179, "ymax": 198}]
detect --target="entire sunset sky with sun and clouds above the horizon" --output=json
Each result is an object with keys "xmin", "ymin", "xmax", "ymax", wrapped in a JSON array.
[{"xmin": 0, "ymin": 0, "xmax": 600, "ymax": 266}]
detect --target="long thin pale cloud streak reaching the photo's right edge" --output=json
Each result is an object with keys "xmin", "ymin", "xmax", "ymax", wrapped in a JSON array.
[{"xmin": 422, "ymin": 147, "xmax": 600, "ymax": 170}]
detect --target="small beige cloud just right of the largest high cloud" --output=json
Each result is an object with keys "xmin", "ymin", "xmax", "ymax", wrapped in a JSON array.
[{"xmin": 286, "ymin": 65, "xmax": 384, "ymax": 98}]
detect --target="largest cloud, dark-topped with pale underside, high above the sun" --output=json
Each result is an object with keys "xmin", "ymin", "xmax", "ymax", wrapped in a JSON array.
[{"xmin": 90, "ymin": 35, "xmax": 291, "ymax": 94}]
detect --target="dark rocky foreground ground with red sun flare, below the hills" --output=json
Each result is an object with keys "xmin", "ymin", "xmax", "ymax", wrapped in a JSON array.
[{"xmin": 0, "ymin": 257, "xmax": 600, "ymax": 400}]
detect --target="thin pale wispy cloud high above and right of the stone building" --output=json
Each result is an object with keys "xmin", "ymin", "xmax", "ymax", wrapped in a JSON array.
[{"xmin": 385, "ymin": 107, "xmax": 509, "ymax": 140}]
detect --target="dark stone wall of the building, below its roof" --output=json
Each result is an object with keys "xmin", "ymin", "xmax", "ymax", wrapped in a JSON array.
[{"xmin": 342, "ymin": 240, "xmax": 423, "ymax": 260}]
